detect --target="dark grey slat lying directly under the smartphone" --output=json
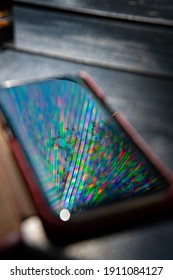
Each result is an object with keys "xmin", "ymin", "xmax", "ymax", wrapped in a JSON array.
[{"xmin": 0, "ymin": 48, "xmax": 173, "ymax": 260}]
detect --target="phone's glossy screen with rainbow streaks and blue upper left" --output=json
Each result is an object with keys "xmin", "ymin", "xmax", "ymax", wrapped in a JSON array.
[{"xmin": 0, "ymin": 79, "xmax": 168, "ymax": 215}]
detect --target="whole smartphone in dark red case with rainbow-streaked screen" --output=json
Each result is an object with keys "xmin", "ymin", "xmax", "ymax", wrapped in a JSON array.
[{"xmin": 0, "ymin": 73, "xmax": 173, "ymax": 244}]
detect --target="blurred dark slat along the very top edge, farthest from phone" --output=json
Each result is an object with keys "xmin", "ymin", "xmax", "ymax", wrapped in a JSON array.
[{"xmin": 14, "ymin": 0, "xmax": 173, "ymax": 26}]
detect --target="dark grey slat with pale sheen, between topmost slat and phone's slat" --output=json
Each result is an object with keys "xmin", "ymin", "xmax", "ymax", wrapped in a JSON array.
[{"xmin": 14, "ymin": 7, "xmax": 173, "ymax": 77}]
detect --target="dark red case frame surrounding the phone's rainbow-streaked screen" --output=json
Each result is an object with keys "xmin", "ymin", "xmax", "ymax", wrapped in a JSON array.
[{"xmin": 0, "ymin": 72, "xmax": 173, "ymax": 243}]
